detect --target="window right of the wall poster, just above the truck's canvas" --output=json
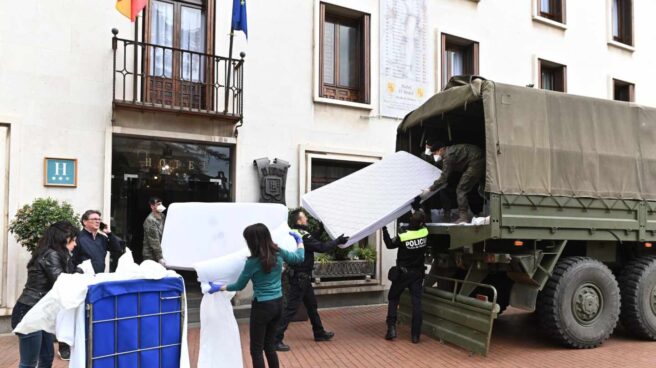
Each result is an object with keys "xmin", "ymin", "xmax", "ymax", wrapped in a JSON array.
[{"xmin": 442, "ymin": 33, "xmax": 478, "ymax": 88}]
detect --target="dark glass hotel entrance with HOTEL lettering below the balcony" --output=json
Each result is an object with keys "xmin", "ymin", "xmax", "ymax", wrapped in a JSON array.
[{"xmin": 111, "ymin": 136, "xmax": 234, "ymax": 262}]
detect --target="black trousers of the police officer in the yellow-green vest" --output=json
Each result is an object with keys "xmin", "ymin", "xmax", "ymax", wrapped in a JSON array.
[{"xmin": 387, "ymin": 270, "xmax": 424, "ymax": 336}]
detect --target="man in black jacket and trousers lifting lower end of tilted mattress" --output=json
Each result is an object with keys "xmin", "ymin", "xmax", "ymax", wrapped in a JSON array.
[{"xmin": 276, "ymin": 209, "xmax": 348, "ymax": 351}]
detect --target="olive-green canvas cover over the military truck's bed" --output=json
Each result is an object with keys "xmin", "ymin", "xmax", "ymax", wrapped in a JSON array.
[{"xmin": 399, "ymin": 78, "xmax": 656, "ymax": 200}]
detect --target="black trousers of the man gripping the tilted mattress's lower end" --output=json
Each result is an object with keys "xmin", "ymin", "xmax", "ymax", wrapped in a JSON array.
[{"xmin": 276, "ymin": 273, "xmax": 324, "ymax": 342}]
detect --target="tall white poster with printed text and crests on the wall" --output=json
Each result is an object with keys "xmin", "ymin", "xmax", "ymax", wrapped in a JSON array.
[{"xmin": 380, "ymin": 0, "xmax": 430, "ymax": 118}]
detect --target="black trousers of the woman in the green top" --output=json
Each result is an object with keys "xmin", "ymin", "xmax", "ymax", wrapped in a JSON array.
[{"xmin": 250, "ymin": 298, "xmax": 282, "ymax": 368}]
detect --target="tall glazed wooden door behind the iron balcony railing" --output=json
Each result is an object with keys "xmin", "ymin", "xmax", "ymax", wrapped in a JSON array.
[{"xmin": 144, "ymin": 0, "xmax": 214, "ymax": 108}]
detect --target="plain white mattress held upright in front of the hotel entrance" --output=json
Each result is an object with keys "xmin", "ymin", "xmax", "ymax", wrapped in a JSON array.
[{"xmin": 162, "ymin": 203, "xmax": 288, "ymax": 269}]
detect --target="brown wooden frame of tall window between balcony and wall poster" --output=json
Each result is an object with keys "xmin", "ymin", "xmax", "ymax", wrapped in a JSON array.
[{"xmin": 319, "ymin": 2, "xmax": 371, "ymax": 104}]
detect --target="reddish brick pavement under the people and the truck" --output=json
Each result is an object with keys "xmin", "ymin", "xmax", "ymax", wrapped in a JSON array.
[{"xmin": 0, "ymin": 306, "xmax": 656, "ymax": 368}]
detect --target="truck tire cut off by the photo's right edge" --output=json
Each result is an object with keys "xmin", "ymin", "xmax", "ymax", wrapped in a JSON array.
[{"xmin": 619, "ymin": 257, "xmax": 656, "ymax": 340}]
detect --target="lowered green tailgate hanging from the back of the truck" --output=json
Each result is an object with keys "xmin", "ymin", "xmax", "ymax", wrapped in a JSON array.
[{"xmin": 398, "ymin": 275, "xmax": 499, "ymax": 356}]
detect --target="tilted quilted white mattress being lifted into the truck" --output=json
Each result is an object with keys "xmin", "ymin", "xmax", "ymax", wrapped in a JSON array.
[{"xmin": 302, "ymin": 151, "xmax": 440, "ymax": 248}]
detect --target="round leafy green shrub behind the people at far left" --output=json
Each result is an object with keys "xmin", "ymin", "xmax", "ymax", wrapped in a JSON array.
[{"xmin": 9, "ymin": 198, "xmax": 80, "ymax": 253}]
